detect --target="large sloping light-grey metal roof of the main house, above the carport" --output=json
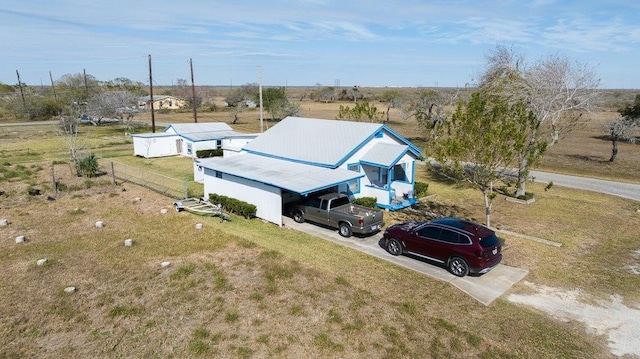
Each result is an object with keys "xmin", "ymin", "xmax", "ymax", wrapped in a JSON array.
[{"xmin": 243, "ymin": 117, "xmax": 384, "ymax": 168}]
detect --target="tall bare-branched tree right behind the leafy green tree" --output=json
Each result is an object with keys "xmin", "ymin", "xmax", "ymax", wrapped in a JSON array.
[{"xmin": 479, "ymin": 46, "xmax": 600, "ymax": 195}]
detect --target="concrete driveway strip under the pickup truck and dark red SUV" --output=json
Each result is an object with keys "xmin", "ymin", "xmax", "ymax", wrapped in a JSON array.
[{"xmin": 283, "ymin": 217, "xmax": 529, "ymax": 305}]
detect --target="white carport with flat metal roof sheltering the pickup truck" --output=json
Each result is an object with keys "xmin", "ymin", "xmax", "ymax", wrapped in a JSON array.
[{"xmin": 200, "ymin": 153, "xmax": 364, "ymax": 226}]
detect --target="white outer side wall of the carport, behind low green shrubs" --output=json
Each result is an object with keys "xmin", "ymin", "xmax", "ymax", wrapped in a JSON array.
[{"xmin": 204, "ymin": 168, "xmax": 282, "ymax": 226}]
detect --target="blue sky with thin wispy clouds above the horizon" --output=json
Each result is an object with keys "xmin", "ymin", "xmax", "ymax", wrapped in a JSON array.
[{"xmin": 0, "ymin": 0, "xmax": 640, "ymax": 89}]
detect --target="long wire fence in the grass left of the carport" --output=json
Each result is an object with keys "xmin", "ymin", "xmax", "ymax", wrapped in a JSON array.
[{"xmin": 106, "ymin": 161, "xmax": 203, "ymax": 198}]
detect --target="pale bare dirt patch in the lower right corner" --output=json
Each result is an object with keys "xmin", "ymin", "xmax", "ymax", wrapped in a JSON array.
[{"xmin": 507, "ymin": 282, "xmax": 640, "ymax": 357}]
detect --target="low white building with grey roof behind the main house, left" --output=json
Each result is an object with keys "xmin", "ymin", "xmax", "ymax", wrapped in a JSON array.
[{"xmin": 131, "ymin": 122, "xmax": 257, "ymax": 158}]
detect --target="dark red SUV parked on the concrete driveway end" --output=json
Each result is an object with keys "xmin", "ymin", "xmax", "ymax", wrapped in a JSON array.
[{"xmin": 383, "ymin": 217, "xmax": 502, "ymax": 277}]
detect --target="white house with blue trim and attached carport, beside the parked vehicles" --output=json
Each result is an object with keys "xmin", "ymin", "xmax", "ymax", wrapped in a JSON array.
[{"xmin": 199, "ymin": 117, "xmax": 421, "ymax": 225}]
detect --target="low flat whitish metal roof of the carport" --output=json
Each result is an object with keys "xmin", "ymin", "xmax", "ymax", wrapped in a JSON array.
[{"xmin": 200, "ymin": 153, "xmax": 364, "ymax": 195}]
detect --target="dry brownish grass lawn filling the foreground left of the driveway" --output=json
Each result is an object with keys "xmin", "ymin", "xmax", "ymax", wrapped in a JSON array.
[{"xmin": 0, "ymin": 167, "xmax": 607, "ymax": 358}]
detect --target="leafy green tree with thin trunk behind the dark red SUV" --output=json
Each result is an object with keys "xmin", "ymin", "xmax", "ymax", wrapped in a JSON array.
[{"xmin": 430, "ymin": 92, "xmax": 535, "ymax": 226}]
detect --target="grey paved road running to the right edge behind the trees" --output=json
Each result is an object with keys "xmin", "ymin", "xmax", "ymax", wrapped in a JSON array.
[{"xmin": 531, "ymin": 171, "xmax": 640, "ymax": 201}]
